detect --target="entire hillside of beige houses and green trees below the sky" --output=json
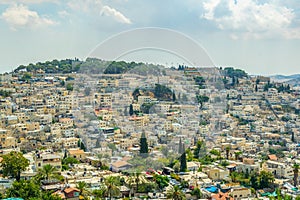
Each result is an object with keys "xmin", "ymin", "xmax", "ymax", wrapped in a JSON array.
[{"xmin": 0, "ymin": 58, "xmax": 300, "ymax": 200}]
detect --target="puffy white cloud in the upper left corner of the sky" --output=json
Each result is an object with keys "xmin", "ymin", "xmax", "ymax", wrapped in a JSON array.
[{"xmin": 1, "ymin": 4, "xmax": 56, "ymax": 30}]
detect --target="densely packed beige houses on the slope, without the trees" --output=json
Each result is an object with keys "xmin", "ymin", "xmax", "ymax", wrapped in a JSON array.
[{"xmin": 0, "ymin": 65, "xmax": 300, "ymax": 199}]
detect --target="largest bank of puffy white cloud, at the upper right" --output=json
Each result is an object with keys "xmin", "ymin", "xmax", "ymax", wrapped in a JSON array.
[{"xmin": 202, "ymin": 0, "xmax": 300, "ymax": 39}]
